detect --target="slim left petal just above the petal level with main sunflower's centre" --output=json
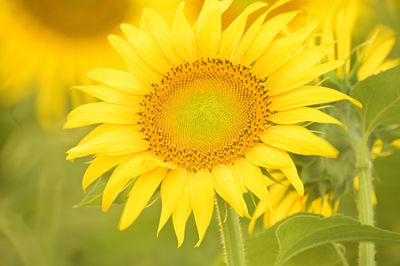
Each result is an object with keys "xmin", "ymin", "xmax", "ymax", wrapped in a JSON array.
[{"xmin": 73, "ymin": 85, "xmax": 145, "ymax": 106}]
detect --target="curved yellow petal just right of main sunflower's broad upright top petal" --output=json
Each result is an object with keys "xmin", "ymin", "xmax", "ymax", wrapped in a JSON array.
[{"xmin": 220, "ymin": 2, "xmax": 267, "ymax": 59}]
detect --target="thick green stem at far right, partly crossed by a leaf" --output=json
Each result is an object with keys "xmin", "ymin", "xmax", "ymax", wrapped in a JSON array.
[{"xmin": 358, "ymin": 134, "xmax": 376, "ymax": 266}]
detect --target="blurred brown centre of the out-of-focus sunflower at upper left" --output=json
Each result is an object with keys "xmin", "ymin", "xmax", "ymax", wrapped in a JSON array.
[{"xmin": 18, "ymin": 0, "xmax": 132, "ymax": 38}]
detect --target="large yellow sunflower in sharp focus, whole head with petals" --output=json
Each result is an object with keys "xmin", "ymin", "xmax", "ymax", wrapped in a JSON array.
[{"xmin": 65, "ymin": 0, "xmax": 360, "ymax": 246}]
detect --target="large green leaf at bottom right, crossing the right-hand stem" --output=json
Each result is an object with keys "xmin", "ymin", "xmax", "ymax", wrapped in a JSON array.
[{"xmin": 247, "ymin": 213, "xmax": 400, "ymax": 266}]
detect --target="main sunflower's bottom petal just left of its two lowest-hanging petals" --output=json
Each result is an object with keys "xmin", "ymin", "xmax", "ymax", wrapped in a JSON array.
[{"xmin": 157, "ymin": 168, "xmax": 187, "ymax": 235}]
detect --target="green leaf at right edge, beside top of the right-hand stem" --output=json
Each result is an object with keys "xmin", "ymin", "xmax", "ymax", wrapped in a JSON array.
[{"xmin": 350, "ymin": 66, "xmax": 400, "ymax": 135}]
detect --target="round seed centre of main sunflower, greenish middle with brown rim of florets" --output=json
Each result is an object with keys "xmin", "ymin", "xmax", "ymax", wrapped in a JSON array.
[{"xmin": 139, "ymin": 59, "xmax": 270, "ymax": 171}]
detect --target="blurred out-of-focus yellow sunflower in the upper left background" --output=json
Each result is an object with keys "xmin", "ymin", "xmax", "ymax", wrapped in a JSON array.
[{"xmin": 0, "ymin": 0, "xmax": 177, "ymax": 127}]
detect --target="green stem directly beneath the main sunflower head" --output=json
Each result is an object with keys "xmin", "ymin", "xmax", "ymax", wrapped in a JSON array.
[{"xmin": 215, "ymin": 196, "xmax": 246, "ymax": 266}]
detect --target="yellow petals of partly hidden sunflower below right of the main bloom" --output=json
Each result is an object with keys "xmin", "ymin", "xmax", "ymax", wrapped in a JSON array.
[{"xmin": 248, "ymin": 178, "xmax": 339, "ymax": 234}]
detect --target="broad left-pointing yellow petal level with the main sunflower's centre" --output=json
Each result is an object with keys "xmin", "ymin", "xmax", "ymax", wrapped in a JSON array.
[{"xmin": 64, "ymin": 102, "xmax": 139, "ymax": 128}]
